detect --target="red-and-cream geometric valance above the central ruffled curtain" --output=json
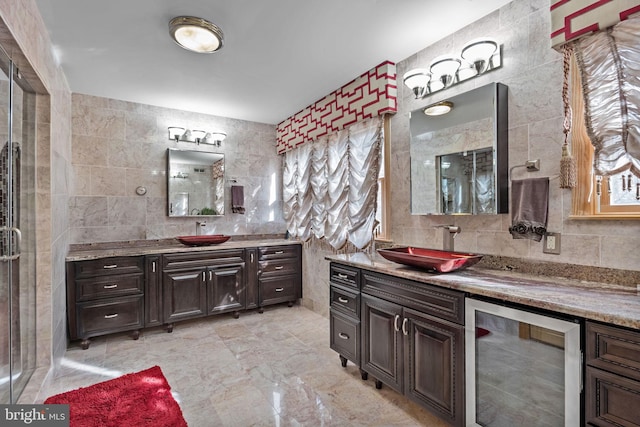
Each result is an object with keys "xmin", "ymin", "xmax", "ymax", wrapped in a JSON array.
[{"xmin": 276, "ymin": 61, "xmax": 398, "ymax": 154}]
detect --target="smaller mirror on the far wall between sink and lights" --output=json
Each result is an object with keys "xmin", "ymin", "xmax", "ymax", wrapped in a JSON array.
[{"xmin": 167, "ymin": 148, "xmax": 224, "ymax": 216}]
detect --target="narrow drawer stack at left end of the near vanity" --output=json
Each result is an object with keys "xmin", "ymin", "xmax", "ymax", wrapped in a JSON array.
[{"xmin": 329, "ymin": 264, "xmax": 360, "ymax": 366}]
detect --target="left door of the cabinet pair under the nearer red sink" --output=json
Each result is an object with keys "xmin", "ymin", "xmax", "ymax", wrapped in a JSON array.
[{"xmin": 361, "ymin": 295, "xmax": 403, "ymax": 393}]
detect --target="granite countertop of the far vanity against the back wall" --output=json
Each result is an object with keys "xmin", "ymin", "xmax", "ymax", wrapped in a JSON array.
[{"xmin": 66, "ymin": 235, "xmax": 301, "ymax": 261}]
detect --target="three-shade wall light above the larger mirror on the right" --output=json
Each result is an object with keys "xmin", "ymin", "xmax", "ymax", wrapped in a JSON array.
[{"xmin": 403, "ymin": 37, "xmax": 502, "ymax": 99}]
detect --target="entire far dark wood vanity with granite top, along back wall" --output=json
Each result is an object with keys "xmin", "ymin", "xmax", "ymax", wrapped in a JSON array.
[{"xmin": 66, "ymin": 239, "xmax": 302, "ymax": 349}]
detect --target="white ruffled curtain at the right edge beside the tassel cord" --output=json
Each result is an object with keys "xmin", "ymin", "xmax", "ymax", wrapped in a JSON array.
[{"xmin": 573, "ymin": 15, "xmax": 640, "ymax": 177}]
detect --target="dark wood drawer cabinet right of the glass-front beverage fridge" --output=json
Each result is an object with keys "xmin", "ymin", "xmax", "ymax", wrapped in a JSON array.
[{"xmin": 585, "ymin": 321, "xmax": 640, "ymax": 427}]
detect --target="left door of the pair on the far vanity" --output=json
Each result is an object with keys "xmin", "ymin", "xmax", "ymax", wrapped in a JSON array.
[{"xmin": 163, "ymin": 268, "xmax": 207, "ymax": 323}]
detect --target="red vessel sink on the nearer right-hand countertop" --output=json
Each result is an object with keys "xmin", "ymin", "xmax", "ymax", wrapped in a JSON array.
[{"xmin": 378, "ymin": 246, "xmax": 482, "ymax": 273}]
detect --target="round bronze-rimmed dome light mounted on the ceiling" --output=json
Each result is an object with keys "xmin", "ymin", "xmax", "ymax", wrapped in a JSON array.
[{"xmin": 169, "ymin": 16, "xmax": 224, "ymax": 53}]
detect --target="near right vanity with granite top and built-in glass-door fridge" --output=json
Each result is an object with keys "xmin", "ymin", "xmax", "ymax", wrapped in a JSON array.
[{"xmin": 327, "ymin": 253, "xmax": 640, "ymax": 426}]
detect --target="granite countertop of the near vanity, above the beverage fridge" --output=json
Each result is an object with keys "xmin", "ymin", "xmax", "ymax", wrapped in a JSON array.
[{"xmin": 326, "ymin": 253, "xmax": 640, "ymax": 329}]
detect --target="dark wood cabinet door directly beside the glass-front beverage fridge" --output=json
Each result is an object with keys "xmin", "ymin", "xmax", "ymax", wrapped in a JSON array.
[{"xmin": 402, "ymin": 308, "xmax": 464, "ymax": 425}]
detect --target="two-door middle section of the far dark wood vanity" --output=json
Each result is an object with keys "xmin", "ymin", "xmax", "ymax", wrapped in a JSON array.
[{"xmin": 162, "ymin": 249, "xmax": 246, "ymax": 330}]
